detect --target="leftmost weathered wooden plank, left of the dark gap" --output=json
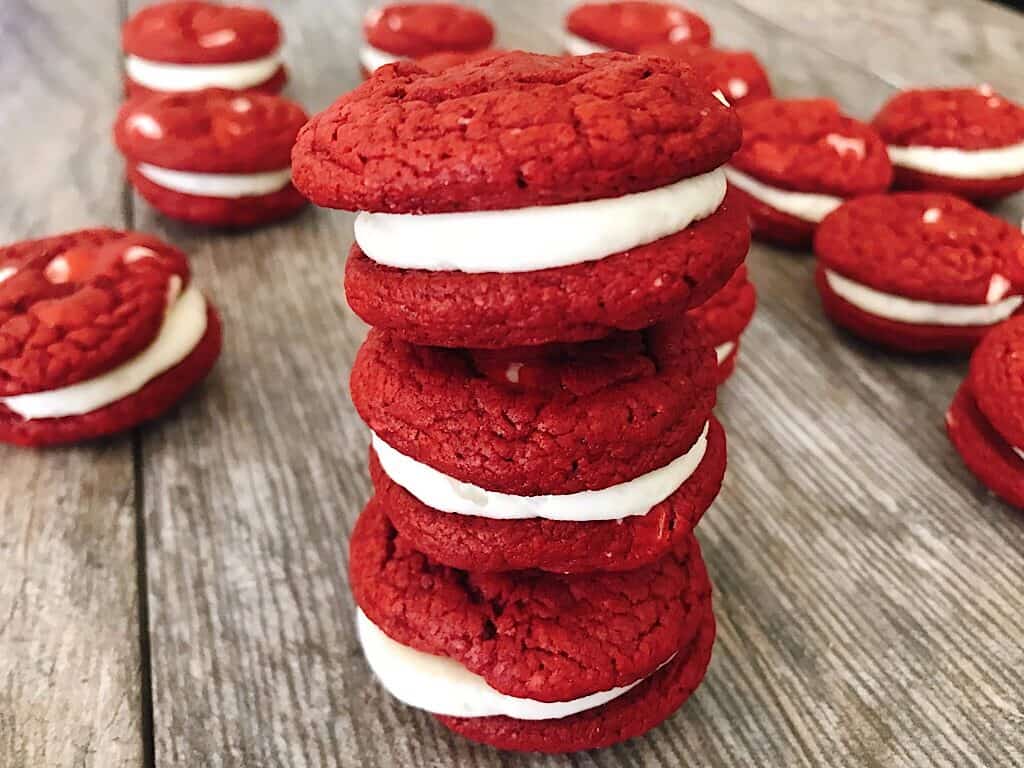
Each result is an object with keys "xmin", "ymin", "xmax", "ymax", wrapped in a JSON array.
[{"xmin": 0, "ymin": 0, "xmax": 143, "ymax": 768}]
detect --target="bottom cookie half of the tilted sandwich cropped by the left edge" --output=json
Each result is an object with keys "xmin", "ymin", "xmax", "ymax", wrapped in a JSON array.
[{"xmin": 0, "ymin": 305, "xmax": 221, "ymax": 447}]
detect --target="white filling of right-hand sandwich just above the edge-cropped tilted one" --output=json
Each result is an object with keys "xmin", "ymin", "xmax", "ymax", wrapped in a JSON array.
[{"xmin": 825, "ymin": 269, "xmax": 1024, "ymax": 327}]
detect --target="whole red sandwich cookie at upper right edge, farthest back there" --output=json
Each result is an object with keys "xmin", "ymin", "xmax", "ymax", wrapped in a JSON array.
[{"xmin": 873, "ymin": 85, "xmax": 1024, "ymax": 200}]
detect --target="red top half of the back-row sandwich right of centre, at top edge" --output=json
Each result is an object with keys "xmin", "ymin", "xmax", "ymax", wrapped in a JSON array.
[{"xmin": 565, "ymin": 0, "xmax": 711, "ymax": 53}]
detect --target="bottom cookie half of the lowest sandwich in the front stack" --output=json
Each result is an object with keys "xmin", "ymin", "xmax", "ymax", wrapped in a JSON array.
[{"xmin": 435, "ymin": 595, "xmax": 715, "ymax": 754}]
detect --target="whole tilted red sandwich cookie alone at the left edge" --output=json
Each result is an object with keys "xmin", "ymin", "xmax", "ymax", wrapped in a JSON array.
[{"xmin": 0, "ymin": 229, "xmax": 220, "ymax": 445}]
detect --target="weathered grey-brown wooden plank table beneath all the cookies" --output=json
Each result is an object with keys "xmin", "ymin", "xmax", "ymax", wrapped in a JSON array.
[{"xmin": 0, "ymin": 0, "xmax": 1024, "ymax": 768}]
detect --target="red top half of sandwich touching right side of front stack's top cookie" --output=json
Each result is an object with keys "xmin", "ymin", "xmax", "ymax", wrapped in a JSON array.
[{"xmin": 730, "ymin": 98, "xmax": 893, "ymax": 198}]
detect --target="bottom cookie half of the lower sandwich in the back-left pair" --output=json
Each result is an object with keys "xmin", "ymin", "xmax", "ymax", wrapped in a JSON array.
[{"xmin": 128, "ymin": 168, "xmax": 307, "ymax": 229}]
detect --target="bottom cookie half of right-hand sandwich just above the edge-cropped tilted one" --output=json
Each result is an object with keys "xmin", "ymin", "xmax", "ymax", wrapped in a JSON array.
[{"xmin": 814, "ymin": 266, "xmax": 992, "ymax": 353}]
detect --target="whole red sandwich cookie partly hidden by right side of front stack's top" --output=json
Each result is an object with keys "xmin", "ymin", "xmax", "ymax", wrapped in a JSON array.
[{"xmin": 726, "ymin": 98, "xmax": 892, "ymax": 247}]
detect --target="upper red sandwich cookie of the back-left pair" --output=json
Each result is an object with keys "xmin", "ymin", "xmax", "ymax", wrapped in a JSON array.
[{"xmin": 121, "ymin": 0, "xmax": 288, "ymax": 96}]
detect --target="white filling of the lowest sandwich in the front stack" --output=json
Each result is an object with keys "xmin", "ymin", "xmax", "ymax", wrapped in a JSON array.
[{"xmin": 355, "ymin": 610, "xmax": 659, "ymax": 720}]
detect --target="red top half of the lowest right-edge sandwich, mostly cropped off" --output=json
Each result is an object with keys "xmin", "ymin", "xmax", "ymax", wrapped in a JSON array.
[{"xmin": 968, "ymin": 316, "xmax": 1024, "ymax": 449}]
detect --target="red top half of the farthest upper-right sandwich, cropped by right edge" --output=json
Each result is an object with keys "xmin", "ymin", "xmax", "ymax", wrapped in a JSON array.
[{"xmin": 871, "ymin": 85, "xmax": 1024, "ymax": 150}]
